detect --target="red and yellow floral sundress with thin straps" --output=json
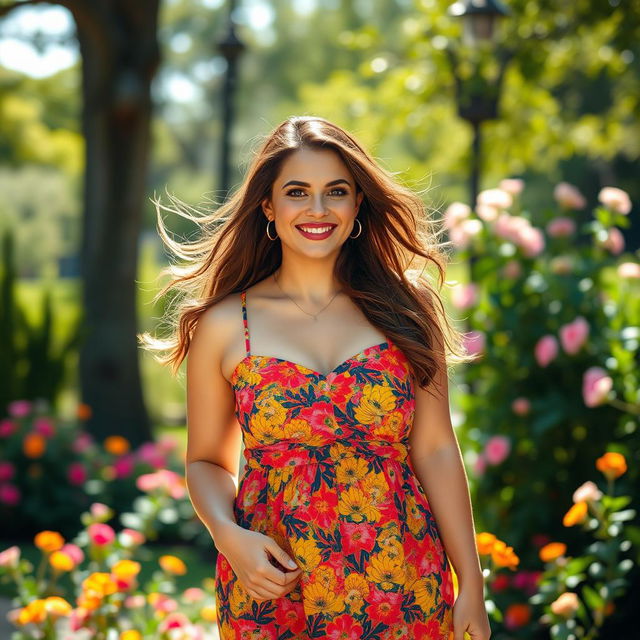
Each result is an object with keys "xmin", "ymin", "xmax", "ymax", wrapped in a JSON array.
[{"xmin": 215, "ymin": 291, "xmax": 454, "ymax": 640}]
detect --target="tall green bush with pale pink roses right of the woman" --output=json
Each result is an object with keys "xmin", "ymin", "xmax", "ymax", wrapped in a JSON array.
[{"xmin": 445, "ymin": 180, "xmax": 640, "ymax": 633}]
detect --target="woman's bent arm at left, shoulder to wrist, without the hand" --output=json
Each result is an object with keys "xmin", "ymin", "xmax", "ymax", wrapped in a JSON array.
[{"xmin": 185, "ymin": 302, "xmax": 242, "ymax": 553}]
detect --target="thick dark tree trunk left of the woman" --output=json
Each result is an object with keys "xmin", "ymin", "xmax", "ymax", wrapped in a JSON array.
[{"xmin": 75, "ymin": 0, "xmax": 159, "ymax": 446}]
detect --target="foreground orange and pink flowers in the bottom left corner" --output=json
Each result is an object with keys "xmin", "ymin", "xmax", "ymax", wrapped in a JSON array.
[{"xmin": 0, "ymin": 470, "xmax": 216, "ymax": 640}]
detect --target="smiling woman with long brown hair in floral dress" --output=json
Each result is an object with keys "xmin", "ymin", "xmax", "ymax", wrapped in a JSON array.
[{"xmin": 140, "ymin": 117, "xmax": 490, "ymax": 640}]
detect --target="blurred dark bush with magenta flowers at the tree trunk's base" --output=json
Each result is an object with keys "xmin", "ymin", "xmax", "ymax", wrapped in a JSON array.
[{"xmin": 0, "ymin": 401, "xmax": 210, "ymax": 544}]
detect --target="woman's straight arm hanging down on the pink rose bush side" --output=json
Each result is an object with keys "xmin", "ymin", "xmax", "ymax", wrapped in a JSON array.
[{"xmin": 409, "ymin": 338, "xmax": 490, "ymax": 640}]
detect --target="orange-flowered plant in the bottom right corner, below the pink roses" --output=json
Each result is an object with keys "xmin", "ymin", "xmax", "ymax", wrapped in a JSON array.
[{"xmin": 531, "ymin": 451, "xmax": 638, "ymax": 640}]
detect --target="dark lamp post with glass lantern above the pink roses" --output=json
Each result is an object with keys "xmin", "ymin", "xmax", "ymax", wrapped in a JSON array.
[{"xmin": 445, "ymin": 0, "xmax": 513, "ymax": 208}]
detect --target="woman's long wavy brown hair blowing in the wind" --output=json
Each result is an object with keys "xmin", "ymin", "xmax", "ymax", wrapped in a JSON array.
[{"xmin": 138, "ymin": 116, "xmax": 472, "ymax": 396}]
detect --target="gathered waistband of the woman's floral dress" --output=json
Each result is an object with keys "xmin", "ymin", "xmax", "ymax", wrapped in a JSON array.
[{"xmin": 244, "ymin": 439, "xmax": 409, "ymax": 469}]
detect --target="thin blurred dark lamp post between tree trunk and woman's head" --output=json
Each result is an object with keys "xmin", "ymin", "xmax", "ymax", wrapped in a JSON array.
[{"xmin": 218, "ymin": 0, "xmax": 246, "ymax": 200}]
